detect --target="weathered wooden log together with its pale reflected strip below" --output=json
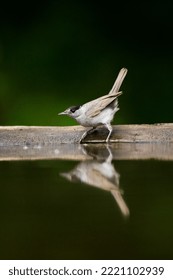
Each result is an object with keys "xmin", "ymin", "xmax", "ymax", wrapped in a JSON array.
[{"xmin": 0, "ymin": 124, "xmax": 173, "ymax": 160}]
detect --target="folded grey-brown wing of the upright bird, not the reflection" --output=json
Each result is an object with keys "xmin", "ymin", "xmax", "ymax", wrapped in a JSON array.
[{"xmin": 85, "ymin": 91, "xmax": 122, "ymax": 118}]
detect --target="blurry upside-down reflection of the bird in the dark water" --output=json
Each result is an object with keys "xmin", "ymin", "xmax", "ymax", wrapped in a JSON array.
[{"xmin": 60, "ymin": 145, "xmax": 130, "ymax": 217}]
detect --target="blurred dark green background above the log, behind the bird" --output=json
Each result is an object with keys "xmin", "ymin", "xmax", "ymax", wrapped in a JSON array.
[{"xmin": 0, "ymin": 0, "xmax": 173, "ymax": 126}]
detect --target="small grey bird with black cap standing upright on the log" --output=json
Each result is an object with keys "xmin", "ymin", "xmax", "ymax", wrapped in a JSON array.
[{"xmin": 58, "ymin": 68, "xmax": 127, "ymax": 143}]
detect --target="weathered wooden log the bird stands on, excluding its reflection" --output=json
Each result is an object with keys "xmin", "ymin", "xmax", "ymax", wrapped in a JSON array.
[{"xmin": 0, "ymin": 123, "xmax": 173, "ymax": 146}]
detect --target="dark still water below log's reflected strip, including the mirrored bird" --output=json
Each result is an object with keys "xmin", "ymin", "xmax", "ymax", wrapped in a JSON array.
[{"xmin": 0, "ymin": 145, "xmax": 173, "ymax": 259}]
